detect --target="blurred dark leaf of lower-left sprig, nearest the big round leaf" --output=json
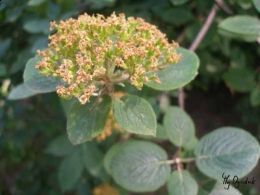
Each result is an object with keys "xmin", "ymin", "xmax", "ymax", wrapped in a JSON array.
[{"xmin": 81, "ymin": 142, "xmax": 108, "ymax": 182}]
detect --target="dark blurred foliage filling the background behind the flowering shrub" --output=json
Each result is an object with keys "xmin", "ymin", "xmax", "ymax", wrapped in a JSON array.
[{"xmin": 0, "ymin": 0, "xmax": 260, "ymax": 195}]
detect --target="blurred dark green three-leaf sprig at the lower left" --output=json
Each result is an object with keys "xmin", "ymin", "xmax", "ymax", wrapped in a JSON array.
[{"xmin": 46, "ymin": 135, "xmax": 108, "ymax": 191}]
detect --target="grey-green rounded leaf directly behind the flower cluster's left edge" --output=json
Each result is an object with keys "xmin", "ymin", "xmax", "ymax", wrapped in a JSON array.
[{"xmin": 23, "ymin": 57, "xmax": 62, "ymax": 93}]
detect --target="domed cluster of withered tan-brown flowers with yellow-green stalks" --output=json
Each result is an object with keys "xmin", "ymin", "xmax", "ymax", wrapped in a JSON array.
[{"xmin": 36, "ymin": 13, "xmax": 181, "ymax": 104}]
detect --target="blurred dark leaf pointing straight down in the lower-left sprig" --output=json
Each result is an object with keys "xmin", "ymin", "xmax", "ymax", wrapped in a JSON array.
[{"xmin": 58, "ymin": 150, "xmax": 84, "ymax": 192}]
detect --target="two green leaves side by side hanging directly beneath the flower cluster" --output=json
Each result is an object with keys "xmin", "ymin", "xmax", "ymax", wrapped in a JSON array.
[{"xmin": 67, "ymin": 95, "xmax": 156, "ymax": 144}]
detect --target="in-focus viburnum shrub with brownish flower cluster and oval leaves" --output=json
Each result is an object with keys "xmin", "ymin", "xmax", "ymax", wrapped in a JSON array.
[{"xmin": 9, "ymin": 11, "xmax": 260, "ymax": 195}]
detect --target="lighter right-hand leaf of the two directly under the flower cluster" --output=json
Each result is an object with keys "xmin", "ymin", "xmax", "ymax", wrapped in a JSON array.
[{"xmin": 113, "ymin": 95, "xmax": 156, "ymax": 135}]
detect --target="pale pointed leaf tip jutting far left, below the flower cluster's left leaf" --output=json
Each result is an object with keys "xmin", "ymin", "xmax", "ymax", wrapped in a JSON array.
[{"xmin": 7, "ymin": 83, "xmax": 37, "ymax": 100}]
